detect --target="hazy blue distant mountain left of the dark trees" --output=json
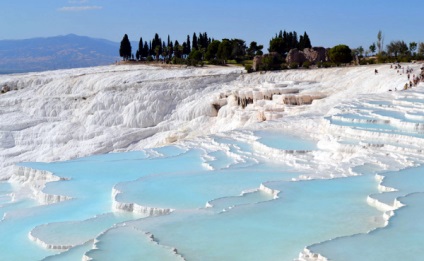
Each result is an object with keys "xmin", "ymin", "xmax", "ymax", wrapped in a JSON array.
[{"xmin": 0, "ymin": 34, "xmax": 119, "ymax": 74}]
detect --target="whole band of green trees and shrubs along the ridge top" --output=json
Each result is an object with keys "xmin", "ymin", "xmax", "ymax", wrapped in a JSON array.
[{"xmin": 119, "ymin": 31, "xmax": 424, "ymax": 71}]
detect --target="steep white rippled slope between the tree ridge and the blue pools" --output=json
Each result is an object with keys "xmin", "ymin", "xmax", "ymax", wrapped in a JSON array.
[{"xmin": 0, "ymin": 62, "xmax": 418, "ymax": 179}]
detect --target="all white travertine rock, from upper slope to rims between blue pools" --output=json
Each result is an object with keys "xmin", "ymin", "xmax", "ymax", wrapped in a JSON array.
[{"xmin": 0, "ymin": 64, "xmax": 424, "ymax": 261}]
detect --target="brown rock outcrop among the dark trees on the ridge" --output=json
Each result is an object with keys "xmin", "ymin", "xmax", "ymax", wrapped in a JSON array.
[{"xmin": 286, "ymin": 47, "xmax": 328, "ymax": 64}]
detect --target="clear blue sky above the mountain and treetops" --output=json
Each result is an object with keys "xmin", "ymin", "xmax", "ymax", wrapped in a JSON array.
[{"xmin": 0, "ymin": 0, "xmax": 424, "ymax": 49}]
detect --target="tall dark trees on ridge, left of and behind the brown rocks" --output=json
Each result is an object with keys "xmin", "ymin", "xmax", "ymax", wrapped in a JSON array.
[{"xmin": 119, "ymin": 31, "xmax": 312, "ymax": 65}]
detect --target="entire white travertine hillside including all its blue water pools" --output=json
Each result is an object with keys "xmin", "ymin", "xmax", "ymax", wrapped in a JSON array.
[{"xmin": 0, "ymin": 64, "xmax": 424, "ymax": 261}]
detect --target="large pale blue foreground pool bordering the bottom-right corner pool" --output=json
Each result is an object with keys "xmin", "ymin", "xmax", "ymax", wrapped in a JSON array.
[{"xmin": 124, "ymin": 175, "xmax": 381, "ymax": 260}]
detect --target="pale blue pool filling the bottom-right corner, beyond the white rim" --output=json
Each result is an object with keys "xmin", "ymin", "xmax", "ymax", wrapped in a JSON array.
[{"xmin": 310, "ymin": 167, "xmax": 424, "ymax": 261}]
